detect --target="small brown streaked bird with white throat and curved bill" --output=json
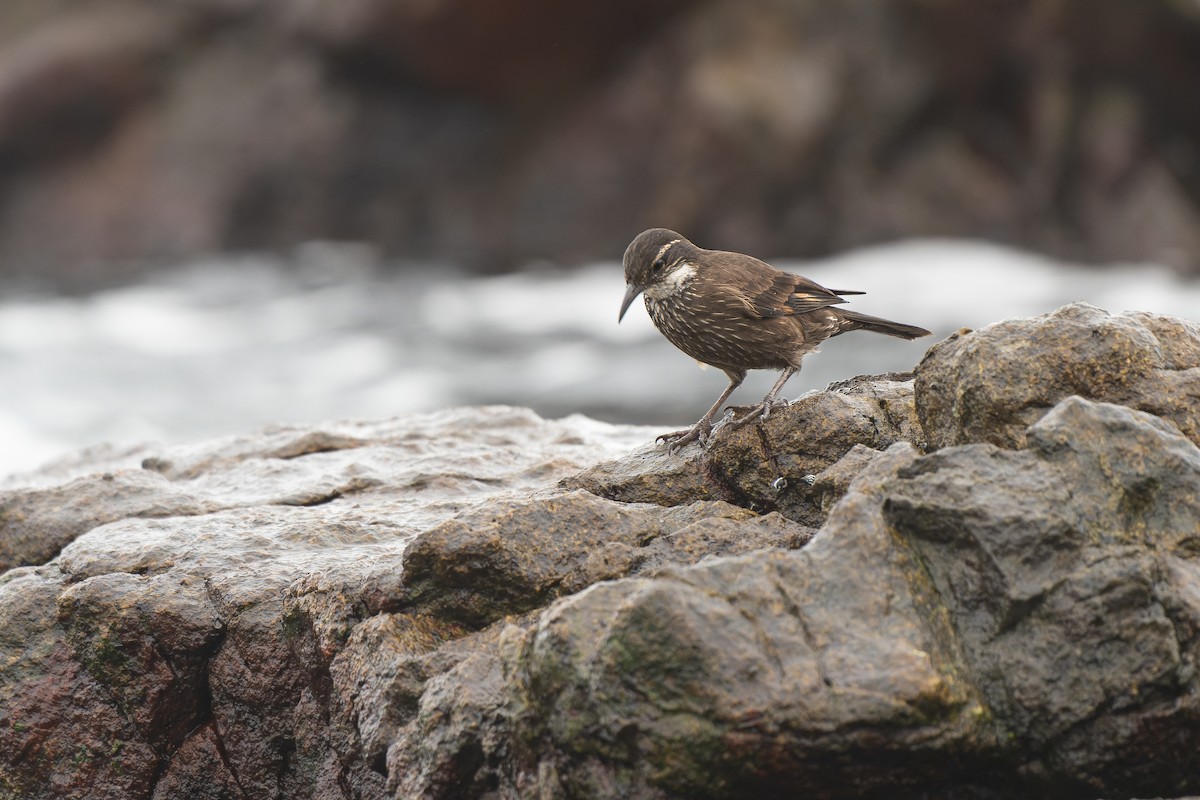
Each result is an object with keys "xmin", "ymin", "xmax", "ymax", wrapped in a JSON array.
[{"xmin": 617, "ymin": 228, "xmax": 930, "ymax": 452}]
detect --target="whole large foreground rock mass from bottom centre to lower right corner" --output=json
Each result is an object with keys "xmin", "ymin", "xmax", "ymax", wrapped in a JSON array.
[{"xmin": 388, "ymin": 398, "xmax": 1200, "ymax": 798}]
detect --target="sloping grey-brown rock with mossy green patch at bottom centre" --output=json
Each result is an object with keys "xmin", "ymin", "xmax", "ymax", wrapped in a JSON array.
[{"xmin": 389, "ymin": 444, "xmax": 995, "ymax": 798}]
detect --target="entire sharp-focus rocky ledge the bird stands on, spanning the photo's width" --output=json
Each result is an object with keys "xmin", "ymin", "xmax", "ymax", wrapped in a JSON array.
[{"xmin": 0, "ymin": 305, "xmax": 1200, "ymax": 800}]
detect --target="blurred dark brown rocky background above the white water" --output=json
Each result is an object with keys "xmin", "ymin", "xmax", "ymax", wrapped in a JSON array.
[{"xmin": 7, "ymin": 0, "xmax": 1200, "ymax": 289}]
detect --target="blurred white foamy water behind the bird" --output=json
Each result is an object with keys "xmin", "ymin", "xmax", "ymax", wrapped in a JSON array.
[{"xmin": 0, "ymin": 241, "xmax": 1200, "ymax": 476}]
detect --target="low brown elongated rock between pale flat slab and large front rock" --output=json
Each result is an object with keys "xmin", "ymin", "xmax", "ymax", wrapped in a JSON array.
[{"xmin": 402, "ymin": 491, "xmax": 811, "ymax": 627}]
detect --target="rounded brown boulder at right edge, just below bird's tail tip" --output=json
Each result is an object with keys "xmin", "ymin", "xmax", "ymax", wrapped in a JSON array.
[{"xmin": 916, "ymin": 303, "xmax": 1200, "ymax": 447}]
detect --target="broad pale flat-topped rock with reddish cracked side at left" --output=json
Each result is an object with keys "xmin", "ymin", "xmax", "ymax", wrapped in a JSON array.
[{"xmin": 0, "ymin": 408, "xmax": 667, "ymax": 798}]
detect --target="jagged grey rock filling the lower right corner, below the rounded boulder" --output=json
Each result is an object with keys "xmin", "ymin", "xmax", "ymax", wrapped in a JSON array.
[{"xmin": 883, "ymin": 397, "xmax": 1200, "ymax": 795}]
